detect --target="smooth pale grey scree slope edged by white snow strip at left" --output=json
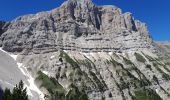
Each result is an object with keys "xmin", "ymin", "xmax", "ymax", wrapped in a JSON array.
[{"xmin": 0, "ymin": 49, "xmax": 43, "ymax": 100}]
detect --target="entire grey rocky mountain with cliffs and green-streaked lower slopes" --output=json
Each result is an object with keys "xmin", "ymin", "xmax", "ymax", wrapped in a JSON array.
[{"xmin": 0, "ymin": 0, "xmax": 170, "ymax": 100}]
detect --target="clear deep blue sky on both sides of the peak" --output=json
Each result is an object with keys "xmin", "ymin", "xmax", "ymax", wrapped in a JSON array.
[{"xmin": 0, "ymin": 0, "xmax": 170, "ymax": 41}]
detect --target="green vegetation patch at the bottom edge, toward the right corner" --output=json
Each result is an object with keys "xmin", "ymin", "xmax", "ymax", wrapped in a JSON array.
[{"xmin": 135, "ymin": 89, "xmax": 162, "ymax": 100}]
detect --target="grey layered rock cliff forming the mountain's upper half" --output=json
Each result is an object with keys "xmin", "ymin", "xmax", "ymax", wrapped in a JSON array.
[{"xmin": 1, "ymin": 0, "xmax": 153, "ymax": 53}]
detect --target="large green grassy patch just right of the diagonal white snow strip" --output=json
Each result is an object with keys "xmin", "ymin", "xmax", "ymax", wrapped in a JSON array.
[{"xmin": 37, "ymin": 71, "xmax": 65, "ymax": 100}]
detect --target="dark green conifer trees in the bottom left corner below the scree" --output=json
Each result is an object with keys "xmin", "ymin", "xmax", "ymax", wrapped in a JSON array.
[{"xmin": 3, "ymin": 81, "xmax": 28, "ymax": 100}]
